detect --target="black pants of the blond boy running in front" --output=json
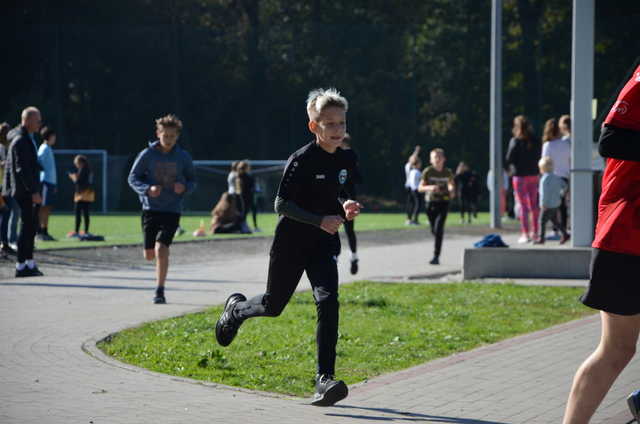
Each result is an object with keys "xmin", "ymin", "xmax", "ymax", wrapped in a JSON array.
[{"xmin": 234, "ymin": 242, "xmax": 339, "ymax": 375}]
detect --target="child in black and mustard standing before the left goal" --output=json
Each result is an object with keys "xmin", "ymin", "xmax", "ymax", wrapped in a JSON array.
[{"xmin": 67, "ymin": 155, "xmax": 96, "ymax": 239}]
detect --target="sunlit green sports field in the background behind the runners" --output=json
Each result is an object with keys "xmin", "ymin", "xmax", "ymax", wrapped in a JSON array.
[{"xmin": 36, "ymin": 213, "xmax": 489, "ymax": 249}]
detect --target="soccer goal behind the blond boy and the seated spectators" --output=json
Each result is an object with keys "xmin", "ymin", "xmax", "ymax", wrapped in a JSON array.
[{"xmin": 185, "ymin": 160, "xmax": 287, "ymax": 212}]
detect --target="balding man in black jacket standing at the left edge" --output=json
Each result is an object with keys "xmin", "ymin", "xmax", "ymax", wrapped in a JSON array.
[{"xmin": 2, "ymin": 106, "xmax": 43, "ymax": 277}]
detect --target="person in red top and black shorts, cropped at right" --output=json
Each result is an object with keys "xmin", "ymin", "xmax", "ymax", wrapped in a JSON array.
[{"xmin": 563, "ymin": 66, "xmax": 640, "ymax": 424}]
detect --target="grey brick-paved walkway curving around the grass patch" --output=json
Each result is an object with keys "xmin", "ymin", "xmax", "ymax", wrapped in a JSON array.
[{"xmin": 0, "ymin": 230, "xmax": 640, "ymax": 424}]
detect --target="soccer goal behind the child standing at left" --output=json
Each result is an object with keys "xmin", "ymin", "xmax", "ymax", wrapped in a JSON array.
[{"xmin": 53, "ymin": 149, "xmax": 109, "ymax": 213}]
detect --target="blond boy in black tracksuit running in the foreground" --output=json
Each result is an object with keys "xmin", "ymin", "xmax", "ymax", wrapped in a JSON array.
[{"xmin": 216, "ymin": 89, "xmax": 362, "ymax": 406}]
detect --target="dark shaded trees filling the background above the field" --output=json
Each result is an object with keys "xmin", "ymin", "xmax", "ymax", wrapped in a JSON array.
[{"xmin": 0, "ymin": 0, "xmax": 640, "ymax": 202}]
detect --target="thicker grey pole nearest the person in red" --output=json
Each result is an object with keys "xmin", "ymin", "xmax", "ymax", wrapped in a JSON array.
[{"xmin": 571, "ymin": 0, "xmax": 594, "ymax": 247}]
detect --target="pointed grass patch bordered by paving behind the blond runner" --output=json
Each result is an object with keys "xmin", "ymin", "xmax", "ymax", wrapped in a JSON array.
[{"xmin": 99, "ymin": 282, "xmax": 592, "ymax": 396}]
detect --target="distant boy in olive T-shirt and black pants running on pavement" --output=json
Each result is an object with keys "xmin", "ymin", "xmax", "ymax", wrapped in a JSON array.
[{"xmin": 418, "ymin": 148, "xmax": 455, "ymax": 265}]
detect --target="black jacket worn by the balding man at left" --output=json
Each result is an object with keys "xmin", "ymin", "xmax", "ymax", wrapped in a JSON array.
[{"xmin": 2, "ymin": 127, "xmax": 42, "ymax": 197}]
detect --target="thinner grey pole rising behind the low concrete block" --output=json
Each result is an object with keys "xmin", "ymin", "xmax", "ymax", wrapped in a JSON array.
[{"xmin": 489, "ymin": 0, "xmax": 502, "ymax": 228}]
